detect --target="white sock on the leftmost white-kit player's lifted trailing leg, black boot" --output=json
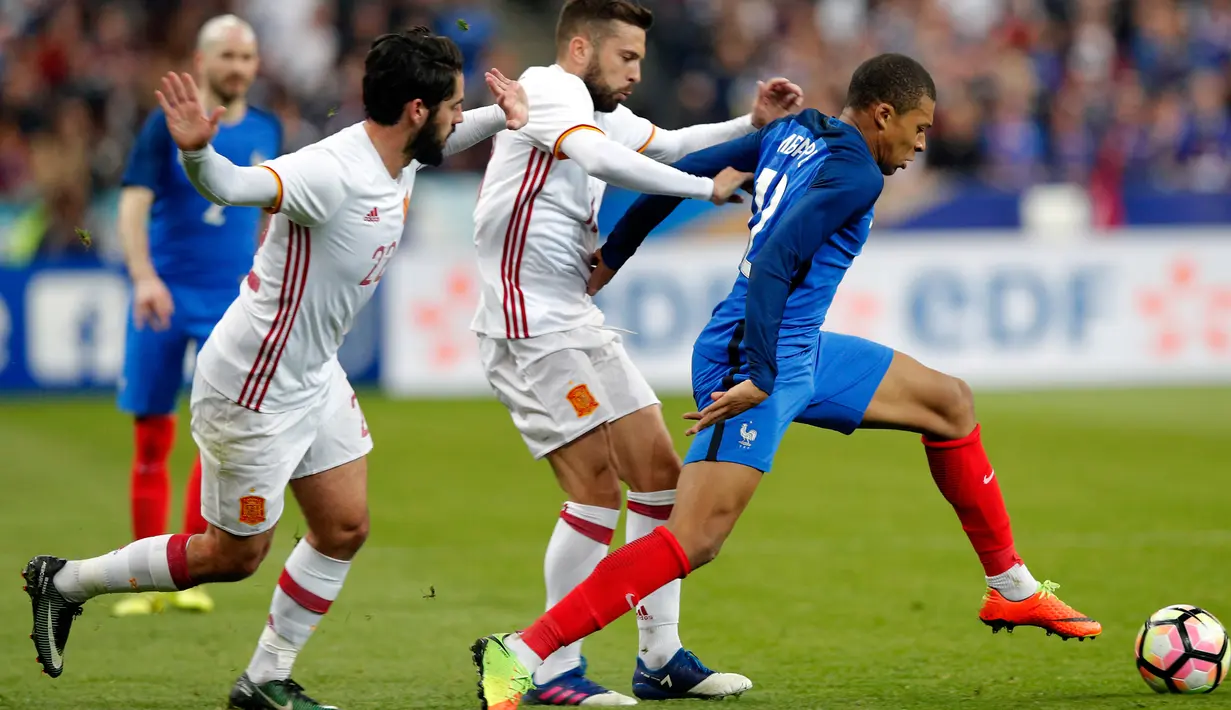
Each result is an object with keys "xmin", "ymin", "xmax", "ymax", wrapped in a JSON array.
[{"xmin": 53, "ymin": 535, "xmax": 193, "ymax": 603}]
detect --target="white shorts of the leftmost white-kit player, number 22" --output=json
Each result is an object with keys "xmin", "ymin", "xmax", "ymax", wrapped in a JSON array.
[{"xmin": 191, "ymin": 365, "xmax": 372, "ymax": 535}]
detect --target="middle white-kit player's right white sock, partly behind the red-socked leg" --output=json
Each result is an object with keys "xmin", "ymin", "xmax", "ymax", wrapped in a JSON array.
[{"xmin": 624, "ymin": 491, "xmax": 683, "ymax": 669}]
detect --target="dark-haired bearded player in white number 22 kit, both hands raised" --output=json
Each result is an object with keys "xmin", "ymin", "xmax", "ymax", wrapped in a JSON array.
[{"xmin": 23, "ymin": 28, "xmax": 527, "ymax": 710}]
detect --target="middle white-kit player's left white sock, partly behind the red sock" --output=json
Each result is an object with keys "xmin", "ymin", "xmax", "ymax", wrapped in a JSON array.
[{"xmin": 534, "ymin": 502, "xmax": 619, "ymax": 684}]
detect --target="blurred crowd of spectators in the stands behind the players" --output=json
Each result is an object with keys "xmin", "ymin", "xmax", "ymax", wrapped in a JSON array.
[{"xmin": 0, "ymin": 0, "xmax": 1231, "ymax": 258}]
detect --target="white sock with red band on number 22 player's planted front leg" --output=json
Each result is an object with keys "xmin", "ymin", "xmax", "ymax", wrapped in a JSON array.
[{"xmin": 247, "ymin": 539, "xmax": 351, "ymax": 684}]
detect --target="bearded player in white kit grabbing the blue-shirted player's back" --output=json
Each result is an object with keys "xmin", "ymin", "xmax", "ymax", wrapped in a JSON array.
[{"xmin": 473, "ymin": 0, "xmax": 803, "ymax": 706}]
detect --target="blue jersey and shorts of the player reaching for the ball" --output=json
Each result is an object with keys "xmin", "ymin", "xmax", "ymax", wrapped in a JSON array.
[{"xmin": 602, "ymin": 110, "xmax": 892, "ymax": 470}]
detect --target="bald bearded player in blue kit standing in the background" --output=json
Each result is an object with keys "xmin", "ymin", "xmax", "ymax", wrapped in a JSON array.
[{"xmin": 113, "ymin": 15, "xmax": 282, "ymax": 615}]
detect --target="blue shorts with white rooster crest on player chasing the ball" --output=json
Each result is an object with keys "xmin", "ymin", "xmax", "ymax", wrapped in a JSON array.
[{"xmin": 684, "ymin": 331, "xmax": 894, "ymax": 471}]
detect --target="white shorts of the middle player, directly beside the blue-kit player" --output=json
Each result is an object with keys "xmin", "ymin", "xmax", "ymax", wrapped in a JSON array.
[{"xmin": 479, "ymin": 326, "xmax": 660, "ymax": 459}]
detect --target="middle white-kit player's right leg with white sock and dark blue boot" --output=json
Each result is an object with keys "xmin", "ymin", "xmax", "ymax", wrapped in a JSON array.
[{"xmin": 608, "ymin": 401, "xmax": 752, "ymax": 700}]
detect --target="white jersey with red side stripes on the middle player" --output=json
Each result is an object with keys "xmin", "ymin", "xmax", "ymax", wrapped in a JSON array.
[{"xmin": 470, "ymin": 64, "xmax": 655, "ymax": 338}]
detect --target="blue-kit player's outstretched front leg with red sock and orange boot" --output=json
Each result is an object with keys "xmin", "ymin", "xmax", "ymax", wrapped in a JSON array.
[{"xmin": 817, "ymin": 332, "xmax": 1102, "ymax": 639}]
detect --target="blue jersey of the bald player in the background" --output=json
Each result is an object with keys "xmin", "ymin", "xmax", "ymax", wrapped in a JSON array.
[{"xmin": 123, "ymin": 107, "xmax": 282, "ymax": 290}]
